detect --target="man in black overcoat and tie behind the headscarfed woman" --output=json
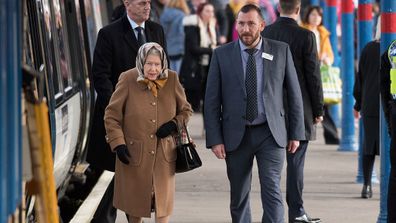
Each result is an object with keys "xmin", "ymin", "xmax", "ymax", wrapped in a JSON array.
[{"xmin": 87, "ymin": 0, "xmax": 166, "ymax": 222}]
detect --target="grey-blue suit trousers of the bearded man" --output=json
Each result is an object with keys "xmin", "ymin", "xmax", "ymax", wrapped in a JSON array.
[{"xmin": 226, "ymin": 123, "xmax": 285, "ymax": 223}]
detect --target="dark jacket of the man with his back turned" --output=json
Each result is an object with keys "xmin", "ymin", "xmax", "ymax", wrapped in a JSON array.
[{"xmin": 262, "ymin": 17, "xmax": 323, "ymax": 140}]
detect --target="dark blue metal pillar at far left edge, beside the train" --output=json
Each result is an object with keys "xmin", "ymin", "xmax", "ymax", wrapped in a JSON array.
[{"xmin": 0, "ymin": 0, "xmax": 22, "ymax": 222}]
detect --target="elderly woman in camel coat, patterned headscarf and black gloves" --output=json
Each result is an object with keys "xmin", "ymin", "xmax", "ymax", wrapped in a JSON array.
[{"xmin": 104, "ymin": 43, "xmax": 192, "ymax": 223}]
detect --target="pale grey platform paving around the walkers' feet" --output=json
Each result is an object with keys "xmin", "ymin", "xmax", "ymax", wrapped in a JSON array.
[{"xmin": 117, "ymin": 114, "xmax": 380, "ymax": 223}]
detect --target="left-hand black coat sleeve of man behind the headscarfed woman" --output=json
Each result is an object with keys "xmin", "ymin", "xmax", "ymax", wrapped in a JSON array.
[{"xmin": 92, "ymin": 29, "xmax": 114, "ymax": 110}]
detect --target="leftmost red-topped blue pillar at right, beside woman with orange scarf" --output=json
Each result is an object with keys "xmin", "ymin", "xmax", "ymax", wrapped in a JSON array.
[{"xmin": 325, "ymin": 0, "xmax": 340, "ymax": 128}]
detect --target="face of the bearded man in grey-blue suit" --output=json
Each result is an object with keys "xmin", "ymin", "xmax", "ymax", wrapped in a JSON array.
[{"xmin": 236, "ymin": 10, "xmax": 265, "ymax": 47}]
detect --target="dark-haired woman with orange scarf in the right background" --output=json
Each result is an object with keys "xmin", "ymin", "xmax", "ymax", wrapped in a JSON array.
[{"xmin": 302, "ymin": 6, "xmax": 340, "ymax": 145}]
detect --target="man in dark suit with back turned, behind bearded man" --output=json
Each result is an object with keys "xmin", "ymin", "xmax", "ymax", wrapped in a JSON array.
[{"xmin": 262, "ymin": 0, "xmax": 323, "ymax": 222}]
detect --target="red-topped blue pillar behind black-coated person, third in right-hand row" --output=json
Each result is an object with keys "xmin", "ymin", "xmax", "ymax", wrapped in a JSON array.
[{"xmin": 356, "ymin": 0, "xmax": 379, "ymax": 183}]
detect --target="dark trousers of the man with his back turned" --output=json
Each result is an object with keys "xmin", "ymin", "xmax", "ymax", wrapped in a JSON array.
[{"xmin": 286, "ymin": 140, "xmax": 308, "ymax": 221}]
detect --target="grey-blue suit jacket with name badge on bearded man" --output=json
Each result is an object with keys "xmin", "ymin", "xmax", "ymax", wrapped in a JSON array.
[{"xmin": 205, "ymin": 38, "xmax": 305, "ymax": 151}]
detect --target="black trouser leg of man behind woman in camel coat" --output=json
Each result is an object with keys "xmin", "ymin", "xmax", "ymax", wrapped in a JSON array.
[{"xmin": 91, "ymin": 177, "xmax": 117, "ymax": 223}]
